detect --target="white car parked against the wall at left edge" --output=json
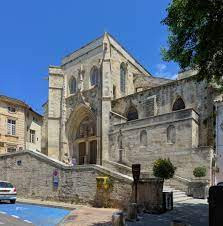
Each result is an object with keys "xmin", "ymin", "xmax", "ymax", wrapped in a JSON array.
[{"xmin": 0, "ymin": 181, "xmax": 16, "ymax": 204}]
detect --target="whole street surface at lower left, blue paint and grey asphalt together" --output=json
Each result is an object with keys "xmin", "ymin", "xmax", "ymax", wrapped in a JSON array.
[{"xmin": 0, "ymin": 203, "xmax": 70, "ymax": 226}]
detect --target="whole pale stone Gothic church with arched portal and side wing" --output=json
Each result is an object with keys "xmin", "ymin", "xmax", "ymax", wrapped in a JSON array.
[{"xmin": 42, "ymin": 33, "xmax": 221, "ymax": 184}]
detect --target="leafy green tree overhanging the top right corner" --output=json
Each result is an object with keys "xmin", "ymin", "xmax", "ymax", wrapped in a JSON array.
[{"xmin": 162, "ymin": 0, "xmax": 223, "ymax": 88}]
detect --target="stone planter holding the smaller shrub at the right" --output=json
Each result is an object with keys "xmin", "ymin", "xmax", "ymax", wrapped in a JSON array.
[{"xmin": 187, "ymin": 179, "xmax": 209, "ymax": 199}]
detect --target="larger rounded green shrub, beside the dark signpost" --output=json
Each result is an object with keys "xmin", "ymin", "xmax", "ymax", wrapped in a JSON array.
[{"xmin": 153, "ymin": 158, "xmax": 176, "ymax": 179}]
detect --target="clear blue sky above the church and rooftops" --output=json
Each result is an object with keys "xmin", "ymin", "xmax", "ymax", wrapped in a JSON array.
[{"xmin": 0, "ymin": 0, "xmax": 178, "ymax": 113}]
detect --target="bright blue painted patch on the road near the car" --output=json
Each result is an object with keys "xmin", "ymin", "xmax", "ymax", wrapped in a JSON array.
[{"xmin": 0, "ymin": 203, "xmax": 70, "ymax": 226}]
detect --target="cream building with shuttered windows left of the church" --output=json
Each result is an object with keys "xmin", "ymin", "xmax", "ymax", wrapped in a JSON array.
[{"xmin": 0, "ymin": 95, "xmax": 42, "ymax": 154}]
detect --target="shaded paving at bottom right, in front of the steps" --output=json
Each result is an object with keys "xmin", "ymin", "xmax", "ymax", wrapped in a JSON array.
[{"xmin": 127, "ymin": 199, "xmax": 208, "ymax": 226}]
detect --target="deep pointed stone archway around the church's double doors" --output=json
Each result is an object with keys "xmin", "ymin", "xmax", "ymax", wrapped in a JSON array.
[{"xmin": 66, "ymin": 104, "xmax": 99, "ymax": 164}]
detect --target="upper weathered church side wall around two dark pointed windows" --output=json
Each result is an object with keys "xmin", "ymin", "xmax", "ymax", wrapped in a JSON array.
[{"xmin": 112, "ymin": 77, "xmax": 214, "ymax": 146}]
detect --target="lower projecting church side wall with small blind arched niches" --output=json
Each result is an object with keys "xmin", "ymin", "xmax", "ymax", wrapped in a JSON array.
[{"xmin": 109, "ymin": 109, "xmax": 212, "ymax": 179}]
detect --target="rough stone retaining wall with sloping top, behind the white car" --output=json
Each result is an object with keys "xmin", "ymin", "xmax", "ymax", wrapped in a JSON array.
[{"xmin": 0, "ymin": 151, "xmax": 132, "ymax": 207}]
